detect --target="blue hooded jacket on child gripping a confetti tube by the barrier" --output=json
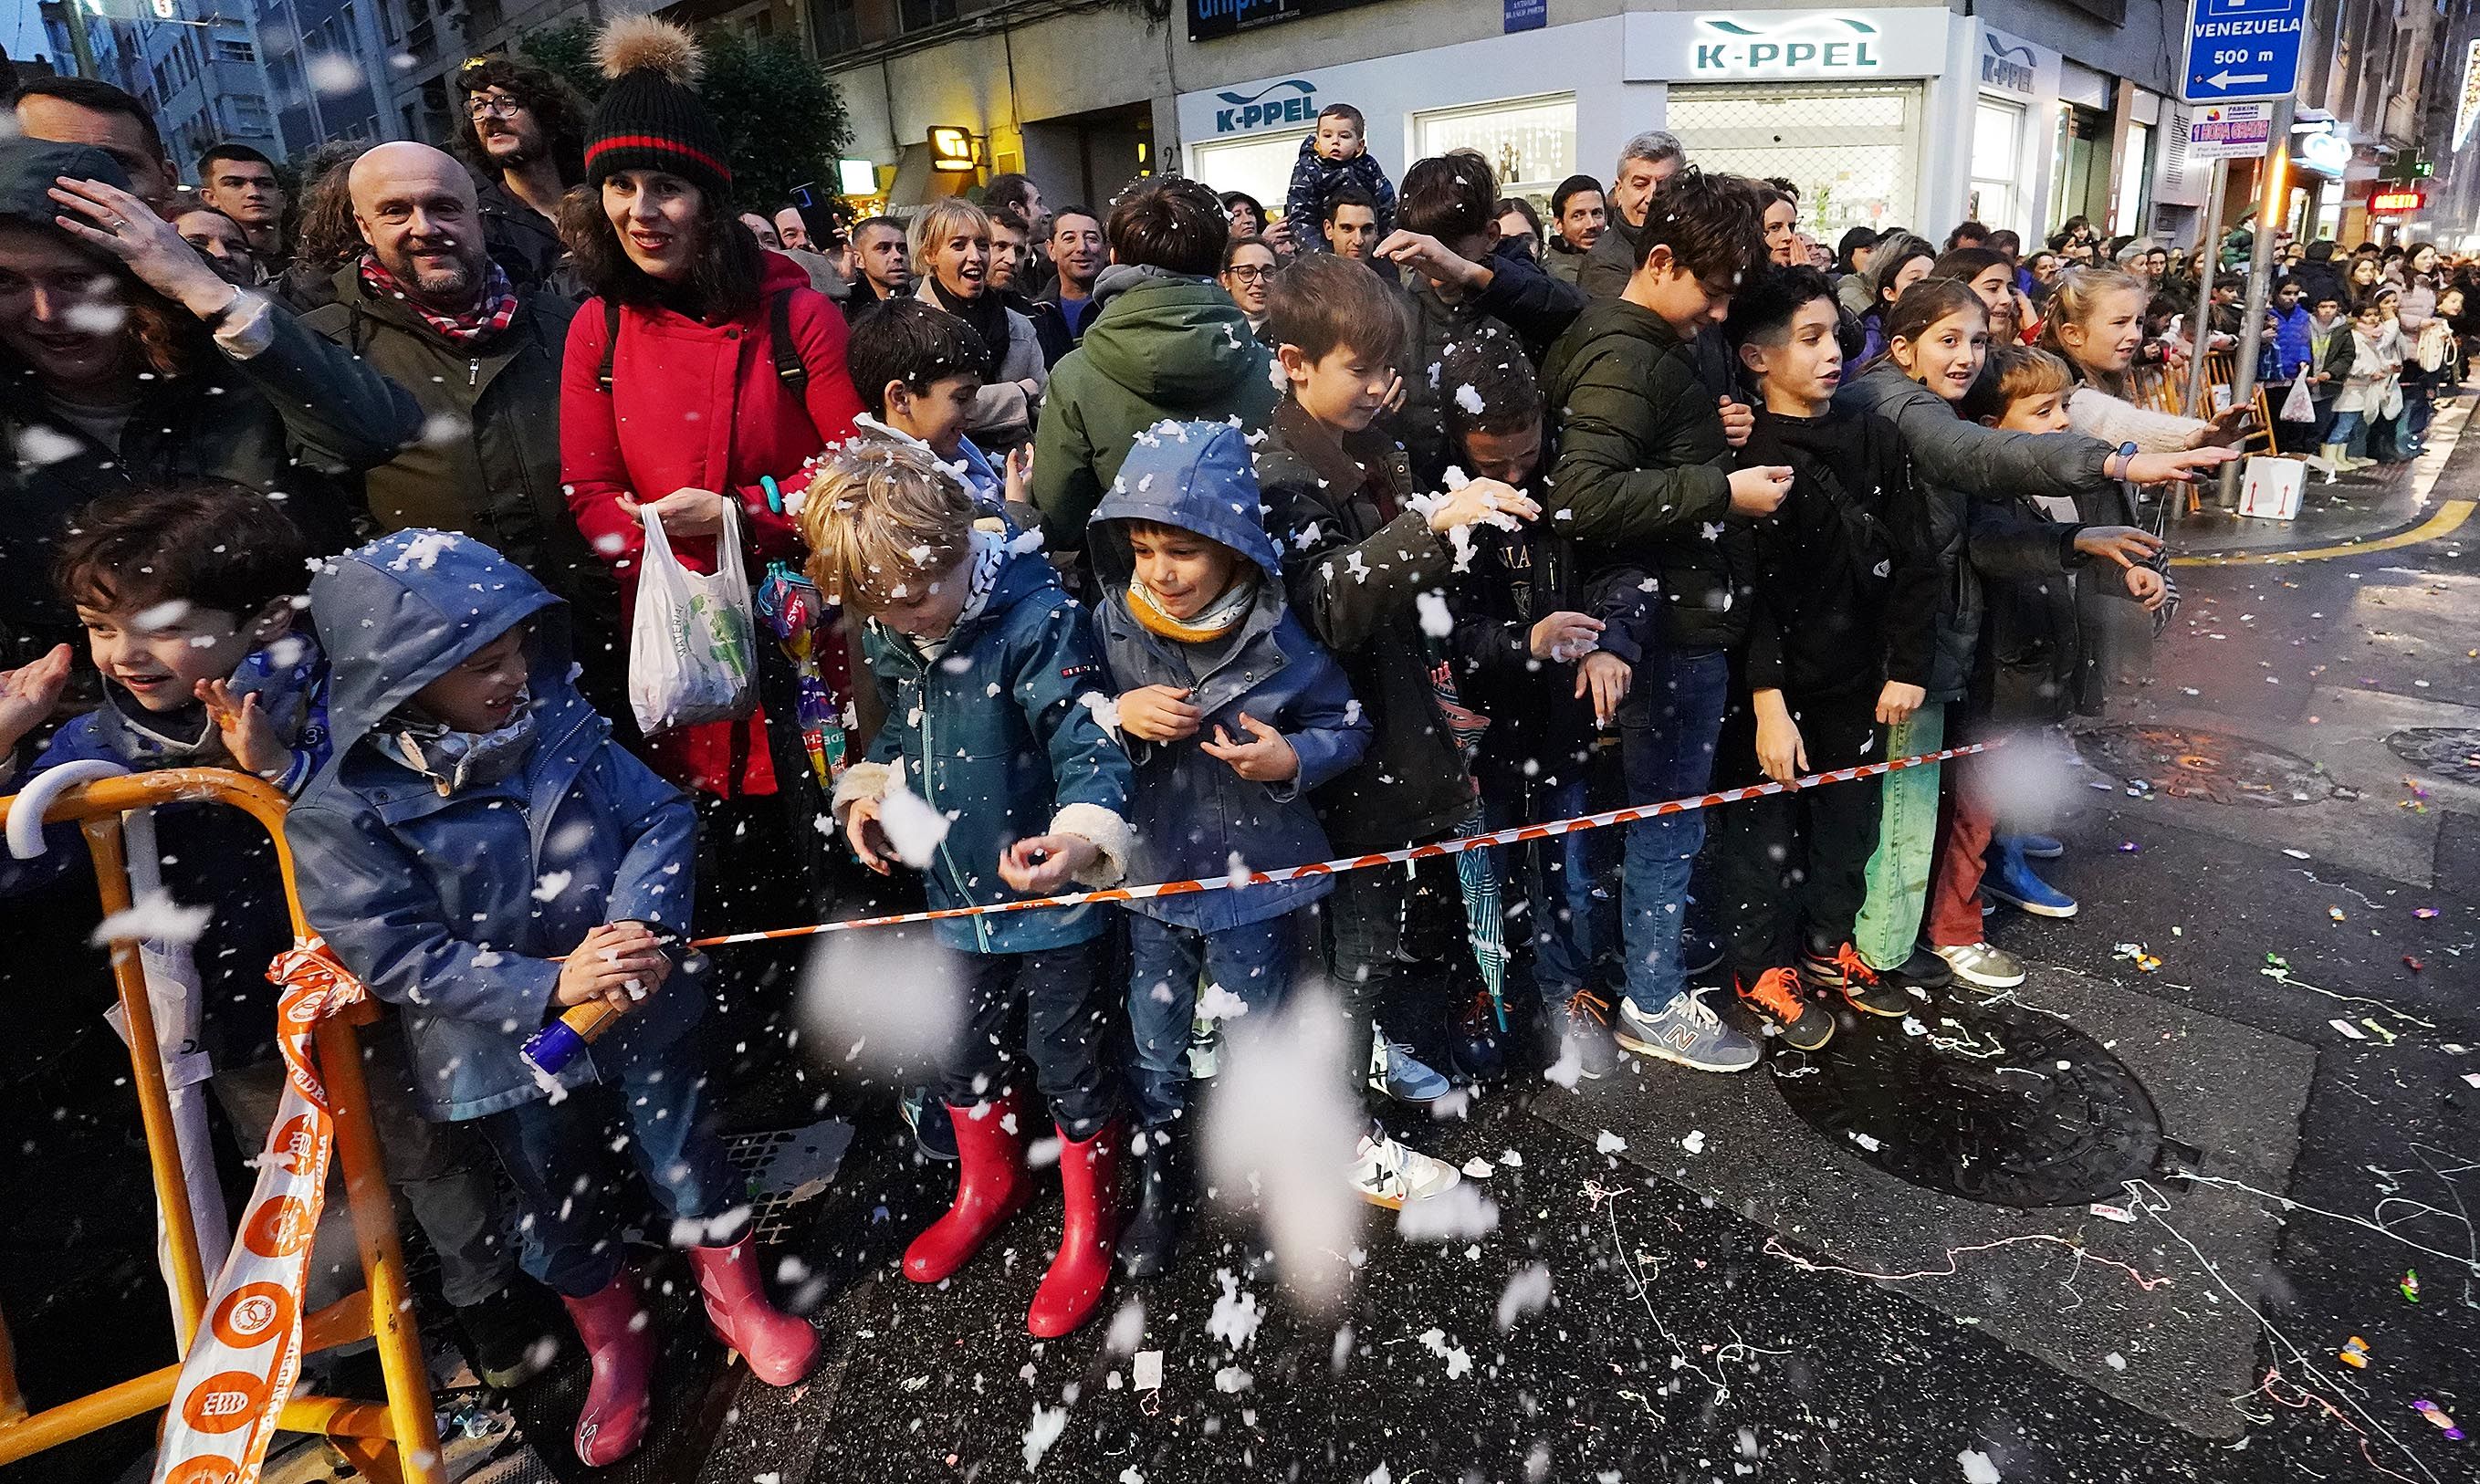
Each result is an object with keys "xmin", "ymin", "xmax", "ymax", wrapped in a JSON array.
[{"xmin": 285, "ymin": 531, "xmax": 705, "ymax": 1119}]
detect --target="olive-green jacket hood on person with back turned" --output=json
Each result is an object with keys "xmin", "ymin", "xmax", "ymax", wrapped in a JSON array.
[{"xmin": 1079, "ymin": 268, "xmax": 1267, "ymax": 407}]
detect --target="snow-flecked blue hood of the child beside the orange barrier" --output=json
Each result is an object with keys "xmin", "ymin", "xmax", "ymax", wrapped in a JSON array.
[{"xmin": 310, "ymin": 531, "xmax": 568, "ymax": 767}]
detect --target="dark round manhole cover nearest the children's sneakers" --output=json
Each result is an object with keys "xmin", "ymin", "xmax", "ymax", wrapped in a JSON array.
[{"xmin": 1774, "ymin": 995, "xmax": 2162, "ymax": 1206}]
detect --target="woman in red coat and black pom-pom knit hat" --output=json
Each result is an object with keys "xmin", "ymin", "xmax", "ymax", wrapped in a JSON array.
[{"xmin": 560, "ymin": 17, "xmax": 861, "ymax": 911}]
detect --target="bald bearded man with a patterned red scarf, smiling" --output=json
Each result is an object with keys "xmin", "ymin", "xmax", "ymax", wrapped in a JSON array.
[{"xmin": 302, "ymin": 141, "xmax": 630, "ymax": 727}]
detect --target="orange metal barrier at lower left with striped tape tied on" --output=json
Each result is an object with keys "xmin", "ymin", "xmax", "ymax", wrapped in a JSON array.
[{"xmin": 0, "ymin": 767, "xmax": 446, "ymax": 1484}]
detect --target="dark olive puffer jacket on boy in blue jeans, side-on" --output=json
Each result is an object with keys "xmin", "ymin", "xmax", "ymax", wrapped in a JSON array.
[{"xmin": 1543, "ymin": 298, "xmax": 1756, "ymax": 650}]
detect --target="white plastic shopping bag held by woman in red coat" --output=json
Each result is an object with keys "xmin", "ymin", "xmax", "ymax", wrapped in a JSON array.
[{"xmin": 627, "ymin": 496, "xmax": 757, "ymax": 737}]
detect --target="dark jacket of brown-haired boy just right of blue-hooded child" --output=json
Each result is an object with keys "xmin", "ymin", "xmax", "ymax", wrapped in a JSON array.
[{"xmin": 1258, "ymin": 402, "xmax": 1473, "ymax": 853}]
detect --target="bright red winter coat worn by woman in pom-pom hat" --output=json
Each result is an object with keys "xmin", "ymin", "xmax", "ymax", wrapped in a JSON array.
[{"xmin": 560, "ymin": 253, "xmax": 861, "ymax": 797}]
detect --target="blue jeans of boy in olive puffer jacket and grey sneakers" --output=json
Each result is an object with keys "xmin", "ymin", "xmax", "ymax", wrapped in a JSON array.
[{"xmin": 1619, "ymin": 650, "xmax": 1731, "ymax": 1015}]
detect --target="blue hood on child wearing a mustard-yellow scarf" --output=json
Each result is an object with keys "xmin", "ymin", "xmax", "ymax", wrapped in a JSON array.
[{"xmin": 1086, "ymin": 420, "xmax": 1282, "ymax": 590}]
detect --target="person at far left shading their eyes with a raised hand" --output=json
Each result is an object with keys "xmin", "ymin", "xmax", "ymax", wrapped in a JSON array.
[{"xmin": 0, "ymin": 139, "xmax": 422, "ymax": 667}]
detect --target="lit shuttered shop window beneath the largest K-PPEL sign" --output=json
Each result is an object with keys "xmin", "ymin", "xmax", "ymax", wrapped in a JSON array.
[{"xmin": 1664, "ymin": 82, "xmax": 1920, "ymax": 241}]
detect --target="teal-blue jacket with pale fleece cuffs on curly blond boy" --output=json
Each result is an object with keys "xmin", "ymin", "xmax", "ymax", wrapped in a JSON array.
[{"xmin": 836, "ymin": 543, "xmax": 1128, "ymax": 953}]
